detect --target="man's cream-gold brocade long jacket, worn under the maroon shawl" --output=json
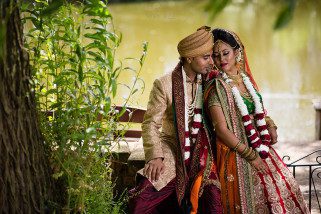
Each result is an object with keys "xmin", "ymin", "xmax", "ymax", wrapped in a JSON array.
[{"xmin": 138, "ymin": 71, "xmax": 196, "ymax": 190}]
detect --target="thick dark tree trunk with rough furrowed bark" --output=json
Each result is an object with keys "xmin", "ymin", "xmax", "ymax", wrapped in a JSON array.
[{"xmin": 0, "ymin": 0, "xmax": 50, "ymax": 213}]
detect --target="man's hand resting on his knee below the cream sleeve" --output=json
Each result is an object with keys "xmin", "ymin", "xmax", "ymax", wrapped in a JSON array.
[{"xmin": 143, "ymin": 158, "xmax": 165, "ymax": 182}]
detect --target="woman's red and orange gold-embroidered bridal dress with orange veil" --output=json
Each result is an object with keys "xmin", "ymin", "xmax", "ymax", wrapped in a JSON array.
[{"xmin": 204, "ymin": 28, "xmax": 309, "ymax": 214}]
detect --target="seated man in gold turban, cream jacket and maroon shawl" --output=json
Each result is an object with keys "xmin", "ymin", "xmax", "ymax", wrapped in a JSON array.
[{"xmin": 129, "ymin": 26, "xmax": 223, "ymax": 214}]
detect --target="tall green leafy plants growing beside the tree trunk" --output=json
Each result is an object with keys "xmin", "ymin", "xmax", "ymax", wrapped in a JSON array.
[{"xmin": 23, "ymin": 0, "xmax": 147, "ymax": 213}]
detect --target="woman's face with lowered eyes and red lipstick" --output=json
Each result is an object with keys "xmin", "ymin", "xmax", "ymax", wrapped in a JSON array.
[{"xmin": 213, "ymin": 41, "xmax": 237, "ymax": 73}]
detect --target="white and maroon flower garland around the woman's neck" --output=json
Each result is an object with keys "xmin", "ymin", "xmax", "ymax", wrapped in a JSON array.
[{"xmin": 222, "ymin": 72, "xmax": 271, "ymax": 159}]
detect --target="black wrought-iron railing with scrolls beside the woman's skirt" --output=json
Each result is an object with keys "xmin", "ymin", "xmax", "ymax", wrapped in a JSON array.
[{"xmin": 282, "ymin": 149, "xmax": 321, "ymax": 213}]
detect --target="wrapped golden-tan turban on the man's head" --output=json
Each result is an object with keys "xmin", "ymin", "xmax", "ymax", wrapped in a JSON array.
[{"xmin": 177, "ymin": 26, "xmax": 214, "ymax": 57}]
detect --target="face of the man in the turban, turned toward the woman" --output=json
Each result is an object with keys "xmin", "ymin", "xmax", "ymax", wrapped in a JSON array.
[{"xmin": 190, "ymin": 50, "xmax": 214, "ymax": 74}]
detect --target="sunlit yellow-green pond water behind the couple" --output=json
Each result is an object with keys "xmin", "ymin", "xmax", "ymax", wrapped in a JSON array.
[{"xmin": 111, "ymin": 1, "xmax": 321, "ymax": 141}]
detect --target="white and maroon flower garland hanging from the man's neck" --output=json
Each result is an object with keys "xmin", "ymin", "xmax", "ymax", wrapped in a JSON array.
[{"xmin": 182, "ymin": 69, "xmax": 203, "ymax": 165}]
